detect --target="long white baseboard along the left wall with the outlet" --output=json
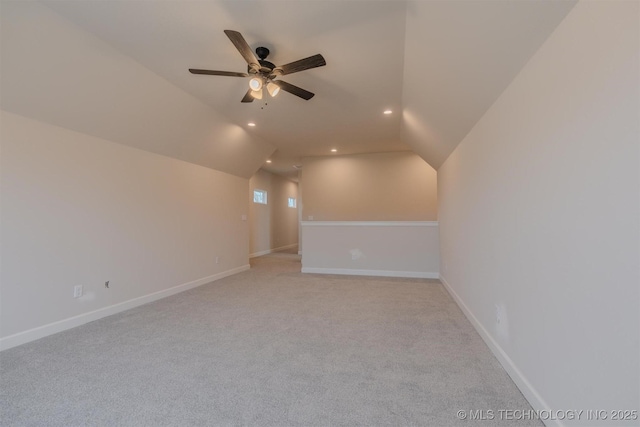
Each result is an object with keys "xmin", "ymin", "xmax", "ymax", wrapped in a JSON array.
[{"xmin": 0, "ymin": 264, "xmax": 250, "ymax": 351}]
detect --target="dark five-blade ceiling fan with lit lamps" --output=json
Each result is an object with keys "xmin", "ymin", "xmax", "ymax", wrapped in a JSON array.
[{"xmin": 189, "ymin": 30, "xmax": 327, "ymax": 102}]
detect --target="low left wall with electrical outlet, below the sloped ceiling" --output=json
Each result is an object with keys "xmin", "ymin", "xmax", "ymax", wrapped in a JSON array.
[{"xmin": 0, "ymin": 112, "xmax": 249, "ymax": 343}]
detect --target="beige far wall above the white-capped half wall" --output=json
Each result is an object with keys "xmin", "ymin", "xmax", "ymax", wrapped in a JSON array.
[{"xmin": 300, "ymin": 152, "xmax": 437, "ymax": 221}]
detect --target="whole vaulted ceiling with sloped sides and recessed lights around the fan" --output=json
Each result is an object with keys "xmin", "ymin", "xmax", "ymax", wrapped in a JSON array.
[{"xmin": 0, "ymin": 0, "xmax": 574, "ymax": 181}]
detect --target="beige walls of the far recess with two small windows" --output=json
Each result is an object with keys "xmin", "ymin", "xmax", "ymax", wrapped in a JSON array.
[{"xmin": 249, "ymin": 169, "xmax": 300, "ymax": 256}]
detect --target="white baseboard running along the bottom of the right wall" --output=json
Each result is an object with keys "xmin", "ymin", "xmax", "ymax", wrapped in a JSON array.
[{"xmin": 440, "ymin": 275, "xmax": 564, "ymax": 427}]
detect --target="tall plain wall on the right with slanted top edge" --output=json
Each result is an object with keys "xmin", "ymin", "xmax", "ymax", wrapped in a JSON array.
[{"xmin": 438, "ymin": 1, "xmax": 640, "ymax": 426}]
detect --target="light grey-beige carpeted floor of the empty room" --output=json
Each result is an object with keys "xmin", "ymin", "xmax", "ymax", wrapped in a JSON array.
[{"xmin": 0, "ymin": 253, "xmax": 541, "ymax": 427}]
